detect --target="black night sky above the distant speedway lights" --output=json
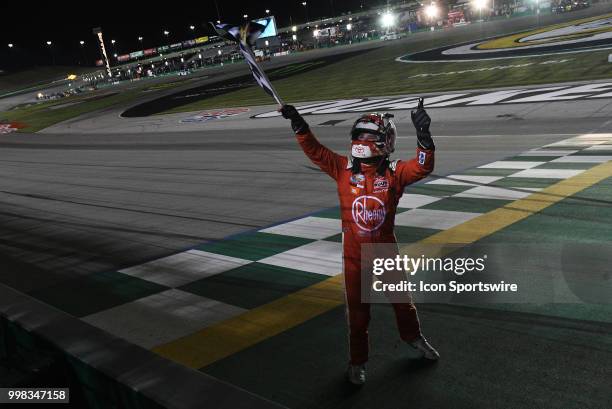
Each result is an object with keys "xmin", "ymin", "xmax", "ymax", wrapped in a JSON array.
[{"xmin": 0, "ymin": 0, "xmax": 387, "ymax": 69}]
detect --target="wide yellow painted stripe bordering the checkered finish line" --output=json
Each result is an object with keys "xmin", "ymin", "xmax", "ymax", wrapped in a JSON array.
[{"xmin": 153, "ymin": 162, "xmax": 612, "ymax": 369}]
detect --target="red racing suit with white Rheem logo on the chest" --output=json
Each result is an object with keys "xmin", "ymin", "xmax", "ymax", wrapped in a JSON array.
[{"xmin": 296, "ymin": 130, "xmax": 434, "ymax": 365}]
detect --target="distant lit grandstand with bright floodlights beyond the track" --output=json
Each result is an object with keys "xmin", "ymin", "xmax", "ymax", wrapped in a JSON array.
[{"xmin": 42, "ymin": 0, "xmax": 588, "ymax": 94}]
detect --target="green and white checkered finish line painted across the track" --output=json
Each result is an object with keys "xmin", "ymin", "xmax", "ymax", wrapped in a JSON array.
[{"xmin": 74, "ymin": 134, "xmax": 612, "ymax": 356}]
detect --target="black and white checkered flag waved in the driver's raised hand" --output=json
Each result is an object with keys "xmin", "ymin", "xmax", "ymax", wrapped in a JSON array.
[{"xmin": 210, "ymin": 21, "xmax": 284, "ymax": 106}]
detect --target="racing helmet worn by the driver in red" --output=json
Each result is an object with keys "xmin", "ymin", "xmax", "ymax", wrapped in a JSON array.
[{"xmin": 351, "ymin": 112, "xmax": 397, "ymax": 159}]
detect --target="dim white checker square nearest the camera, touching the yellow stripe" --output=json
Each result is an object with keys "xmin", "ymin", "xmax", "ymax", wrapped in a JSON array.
[{"xmin": 82, "ymin": 289, "xmax": 246, "ymax": 349}]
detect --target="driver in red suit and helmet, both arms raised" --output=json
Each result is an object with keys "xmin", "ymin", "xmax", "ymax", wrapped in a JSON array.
[{"xmin": 280, "ymin": 99, "xmax": 439, "ymax": 385}]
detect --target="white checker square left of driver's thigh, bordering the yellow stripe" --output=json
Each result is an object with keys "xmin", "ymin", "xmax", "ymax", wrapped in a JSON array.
[{"xmin": 259, "ymin": 241, "xmax": 342, "ymax": 276}]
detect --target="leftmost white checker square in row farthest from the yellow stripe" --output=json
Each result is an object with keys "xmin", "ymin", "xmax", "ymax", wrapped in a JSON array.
[{"xmin": 119, "ymin": 250, "xmax": 251, "ymax": 287}]
